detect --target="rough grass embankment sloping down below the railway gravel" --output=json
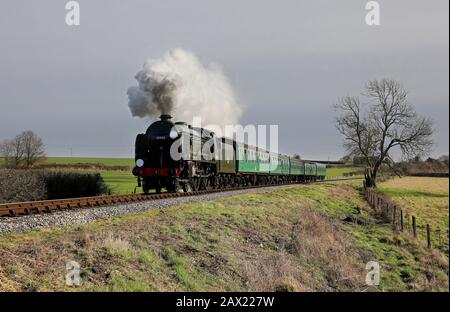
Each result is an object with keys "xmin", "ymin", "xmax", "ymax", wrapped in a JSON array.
[{"xmin": 0, "ymin": 184, "xmax": 448, "ymax": 291}]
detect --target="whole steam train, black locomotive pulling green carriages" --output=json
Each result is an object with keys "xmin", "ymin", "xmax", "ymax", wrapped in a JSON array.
[{"xmin": 133, "ymin": 114, "xmax": 326, "ymax": 193}]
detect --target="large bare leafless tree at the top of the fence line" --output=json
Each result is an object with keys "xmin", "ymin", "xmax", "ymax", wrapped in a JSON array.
[{"xmin": 335, "ymin": 79, "xmax": 433, "ymax": 187}]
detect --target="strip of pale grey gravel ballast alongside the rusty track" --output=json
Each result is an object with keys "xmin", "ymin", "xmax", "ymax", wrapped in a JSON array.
[{"xmin": 0, "ymin": 186, "xmax": 277, "ymax": 236}]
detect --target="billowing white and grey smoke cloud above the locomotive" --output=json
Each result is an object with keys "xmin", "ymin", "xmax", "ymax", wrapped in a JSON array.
[{"xmin": 127, "ymin": 49, "xmax": 243, "ymax": 127}]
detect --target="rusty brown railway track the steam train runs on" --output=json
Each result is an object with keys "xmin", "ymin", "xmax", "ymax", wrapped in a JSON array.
[{"xmin": 0, "ymin": 178, "xmax": 361, "ymax": 217}]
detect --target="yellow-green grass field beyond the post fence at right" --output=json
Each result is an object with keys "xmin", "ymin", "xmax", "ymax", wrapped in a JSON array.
[{"xmin": 379, "ymin": 177, "xmax": 449, "ymax": 231}]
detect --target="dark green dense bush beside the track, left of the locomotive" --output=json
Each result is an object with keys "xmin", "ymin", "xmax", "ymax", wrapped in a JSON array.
[{"xmin": 45, "ymin": 172, "xmax": 110, "ymax": 199}]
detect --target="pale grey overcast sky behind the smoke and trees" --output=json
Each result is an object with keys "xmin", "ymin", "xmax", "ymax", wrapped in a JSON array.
[{"xmin": 0, "ymin": 0, "xmax": 449, "ymax": 159}]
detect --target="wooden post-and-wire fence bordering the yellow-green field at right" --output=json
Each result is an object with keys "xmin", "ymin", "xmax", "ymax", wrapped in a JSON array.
[{"xmin": 363, "ymin": 185, "xmax": 449, "ymax": 251}]
